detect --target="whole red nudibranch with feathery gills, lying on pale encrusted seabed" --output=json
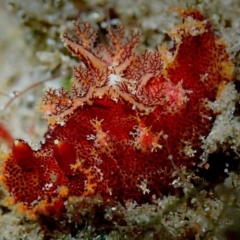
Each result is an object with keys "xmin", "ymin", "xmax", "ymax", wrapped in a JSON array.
[{"xmin": 2, "ymin": 10, "xmax": 234, "ymax": 218}]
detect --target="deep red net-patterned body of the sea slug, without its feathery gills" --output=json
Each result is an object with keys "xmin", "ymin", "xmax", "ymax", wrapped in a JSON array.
[{"xmin": 3, "ymin": 8, "xmax": 234, "ymax": 216}]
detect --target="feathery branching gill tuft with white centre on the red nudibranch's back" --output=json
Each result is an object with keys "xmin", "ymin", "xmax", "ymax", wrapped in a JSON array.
[{"xmin": 56, "ymin": 23, "xmax": 185, "ymax": 115}]
